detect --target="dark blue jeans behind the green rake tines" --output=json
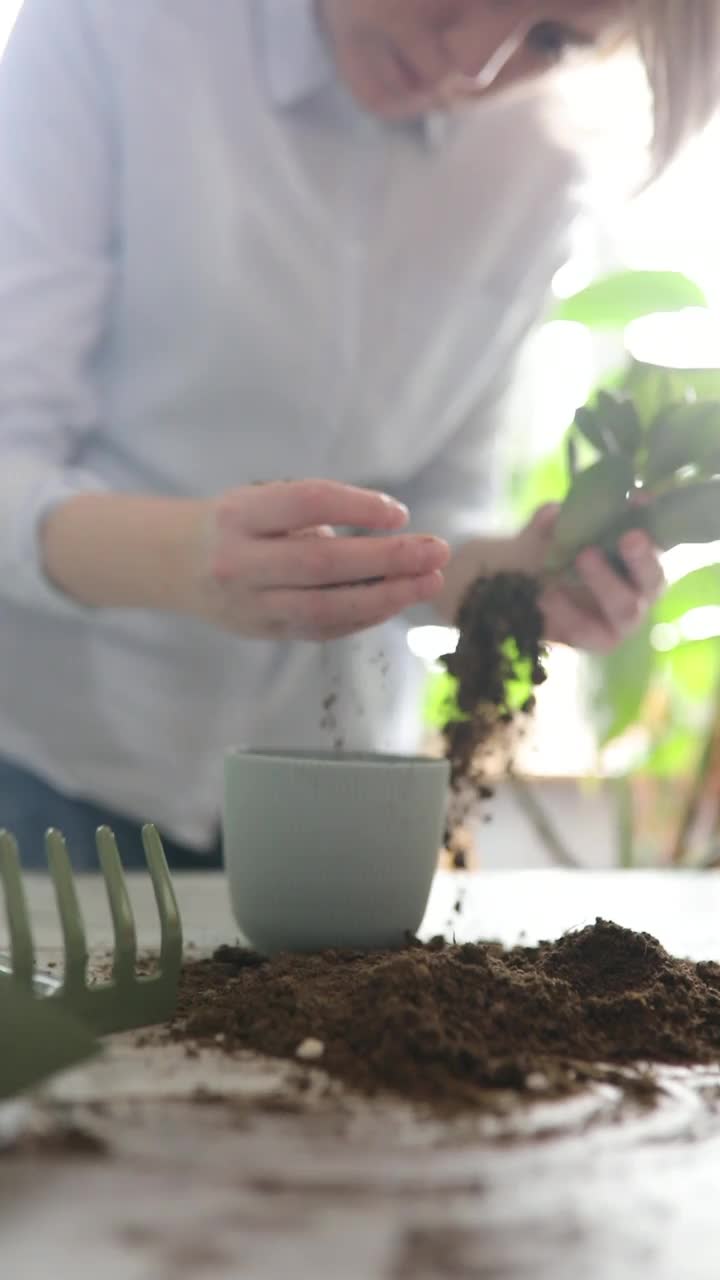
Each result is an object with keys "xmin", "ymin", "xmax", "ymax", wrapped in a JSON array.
[{"xmin": 0, "ymin": 759, "xmax": 223, "ymax": 872}]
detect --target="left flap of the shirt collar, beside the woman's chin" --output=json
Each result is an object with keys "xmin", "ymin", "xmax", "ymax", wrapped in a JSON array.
[{"xmin": 256, "ymin": 0, "xmax": 336, "ymax": 108}]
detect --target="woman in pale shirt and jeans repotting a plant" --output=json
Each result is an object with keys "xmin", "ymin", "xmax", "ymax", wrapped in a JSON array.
[{"xmin": 0, "ymin": 0, "xmax": 720, "ymax": 867}]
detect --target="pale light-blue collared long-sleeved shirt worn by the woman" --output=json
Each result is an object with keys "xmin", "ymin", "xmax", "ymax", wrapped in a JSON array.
[{"xmin": 0, "ymin": 0, "xmax": 574, "ymax": 847}]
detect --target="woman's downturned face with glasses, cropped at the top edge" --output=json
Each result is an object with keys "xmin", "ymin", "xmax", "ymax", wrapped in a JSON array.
[{"xmin": 316, "ymin": 0, "xmax": 632, "ymax": 119}]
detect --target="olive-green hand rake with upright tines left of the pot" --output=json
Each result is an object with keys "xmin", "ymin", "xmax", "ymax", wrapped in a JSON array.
[{"xmin": 0, "ymin": 826, "xmax": 182, "ymax": 1039}]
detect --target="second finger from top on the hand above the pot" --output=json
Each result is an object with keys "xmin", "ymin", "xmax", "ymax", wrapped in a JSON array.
[{"xmin": 241, "ymin": 535, "xmax": 450, "ymax": 590}]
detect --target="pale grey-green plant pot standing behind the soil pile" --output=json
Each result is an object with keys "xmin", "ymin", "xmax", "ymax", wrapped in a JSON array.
[{"xmin": 224, "ymin": 750, "xmax": 450, "ymax": 955}]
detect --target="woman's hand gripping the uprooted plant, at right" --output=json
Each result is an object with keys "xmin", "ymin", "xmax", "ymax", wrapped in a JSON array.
[{"xmin": 516, "ymin": 506, "xmax": 665, "ymax": 653}]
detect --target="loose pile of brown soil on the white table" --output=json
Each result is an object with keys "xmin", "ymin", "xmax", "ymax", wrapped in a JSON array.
[{"xmin": 172, "ymin": 920, "xmax": 720, "ymax": 1110}]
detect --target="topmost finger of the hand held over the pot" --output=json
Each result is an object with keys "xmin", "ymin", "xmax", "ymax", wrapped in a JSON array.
[{"xmin": 218, "ymin": 480, "xmax": 407, "ymax": 538}]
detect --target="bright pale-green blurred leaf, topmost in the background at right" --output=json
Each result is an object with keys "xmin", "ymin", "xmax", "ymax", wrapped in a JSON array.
[{"xmin": 551, "ymin": 271, "xmax": 707, "ymax": 333}]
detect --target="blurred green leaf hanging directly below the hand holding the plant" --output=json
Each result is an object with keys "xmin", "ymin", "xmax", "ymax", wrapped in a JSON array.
[{"xmin": 592, "ymin": 620, "xmax": 656, "ymax": 746}]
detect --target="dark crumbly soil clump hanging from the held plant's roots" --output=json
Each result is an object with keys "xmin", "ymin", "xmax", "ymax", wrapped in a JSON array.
[{"xmin": 443, "ymin": 573, "xmax": 546, "ymax": 800}]
